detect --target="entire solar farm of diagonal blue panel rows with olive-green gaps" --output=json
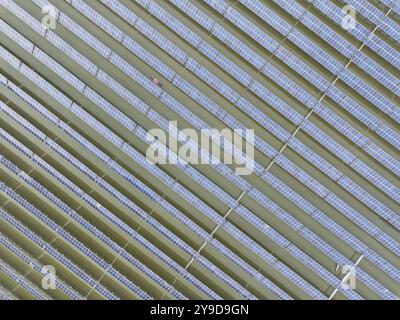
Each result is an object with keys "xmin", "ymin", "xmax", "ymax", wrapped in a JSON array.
[{"xmin": 0, "ymin": 0, "xmax": 400, "ymax": 300}]
